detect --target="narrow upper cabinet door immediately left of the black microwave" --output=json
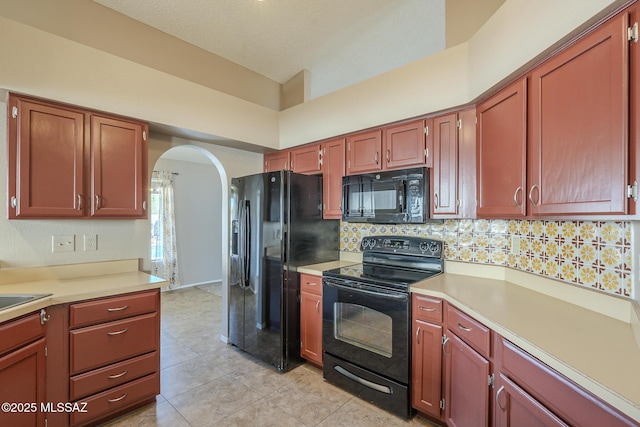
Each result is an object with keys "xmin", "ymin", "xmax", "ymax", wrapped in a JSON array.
[{"xmin": 322, "ymin": 138, "xmax": 345, "ymax": 219}]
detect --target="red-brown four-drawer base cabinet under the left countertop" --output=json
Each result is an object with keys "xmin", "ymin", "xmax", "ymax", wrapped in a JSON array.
[{"xmin": 68, "ymin": 290, "xmax": 160, "ymax": 426}]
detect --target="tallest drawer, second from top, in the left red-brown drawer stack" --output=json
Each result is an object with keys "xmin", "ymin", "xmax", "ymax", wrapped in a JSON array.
[{"xmin": 69, "ymin": 313, "xmax": 159, "ymax": 374}]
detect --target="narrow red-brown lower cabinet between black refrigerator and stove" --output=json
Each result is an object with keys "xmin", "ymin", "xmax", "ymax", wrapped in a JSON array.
[{"xmin": 300, "ymin": 274, "xmax": 322, "ymax": 366}]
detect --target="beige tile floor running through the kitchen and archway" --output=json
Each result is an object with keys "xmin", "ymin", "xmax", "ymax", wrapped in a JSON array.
[{"xmin": 106, "ymin": 285, "xmax": 432, "ymax": 427}]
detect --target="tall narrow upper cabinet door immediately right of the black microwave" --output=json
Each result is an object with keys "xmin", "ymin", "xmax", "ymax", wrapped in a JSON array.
[{"xmin": 431, "ymin": 113, "xmax": 459, "ymax": 217}]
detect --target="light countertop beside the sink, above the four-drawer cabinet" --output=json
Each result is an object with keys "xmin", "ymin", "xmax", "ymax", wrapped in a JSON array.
[{"xmin": 0, "ymin": 260, "xmax": 166, "ymax": 322}]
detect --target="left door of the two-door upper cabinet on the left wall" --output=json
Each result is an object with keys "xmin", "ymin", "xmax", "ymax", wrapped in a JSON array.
[{"xmin": 8, "ymin": 96, "xmax": 85, "ymax": 218}]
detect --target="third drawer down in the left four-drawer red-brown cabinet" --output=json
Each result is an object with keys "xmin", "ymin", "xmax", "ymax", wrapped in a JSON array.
[{"xmin": 69, "ymin": 351, "xmax": 160, "ymax": 400}]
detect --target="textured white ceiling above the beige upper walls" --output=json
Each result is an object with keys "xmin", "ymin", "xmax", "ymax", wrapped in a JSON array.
[{"xmin": 94, "ymin": 0, "xmax": 445, "ymax": 98}]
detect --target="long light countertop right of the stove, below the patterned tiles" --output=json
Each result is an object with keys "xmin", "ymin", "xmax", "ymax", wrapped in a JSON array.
[{"xmin": 411, "ymin": 273, "xmax": 640, "ymax": 421}]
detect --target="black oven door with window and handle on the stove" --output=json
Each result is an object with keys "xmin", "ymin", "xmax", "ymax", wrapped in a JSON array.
[{"xmin": 322, "ymin": 277, "xmax": 411, "ymax": 384}]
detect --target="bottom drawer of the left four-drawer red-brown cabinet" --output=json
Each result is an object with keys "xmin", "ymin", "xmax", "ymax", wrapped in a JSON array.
[{"xmin": 71, "ymin": 373, "xmax": 160, "ymax": 426}]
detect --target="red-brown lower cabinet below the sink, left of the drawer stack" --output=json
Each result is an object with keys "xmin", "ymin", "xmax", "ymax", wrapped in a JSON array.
[{"xmin": 0, "ymin": 313, "xmax": 47, "ymax": 427}]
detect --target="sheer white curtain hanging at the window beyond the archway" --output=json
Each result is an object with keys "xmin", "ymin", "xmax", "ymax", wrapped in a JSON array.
[{"xmin": 152, "ymin": 171, "xmax": 180, "ymax": 289}]
